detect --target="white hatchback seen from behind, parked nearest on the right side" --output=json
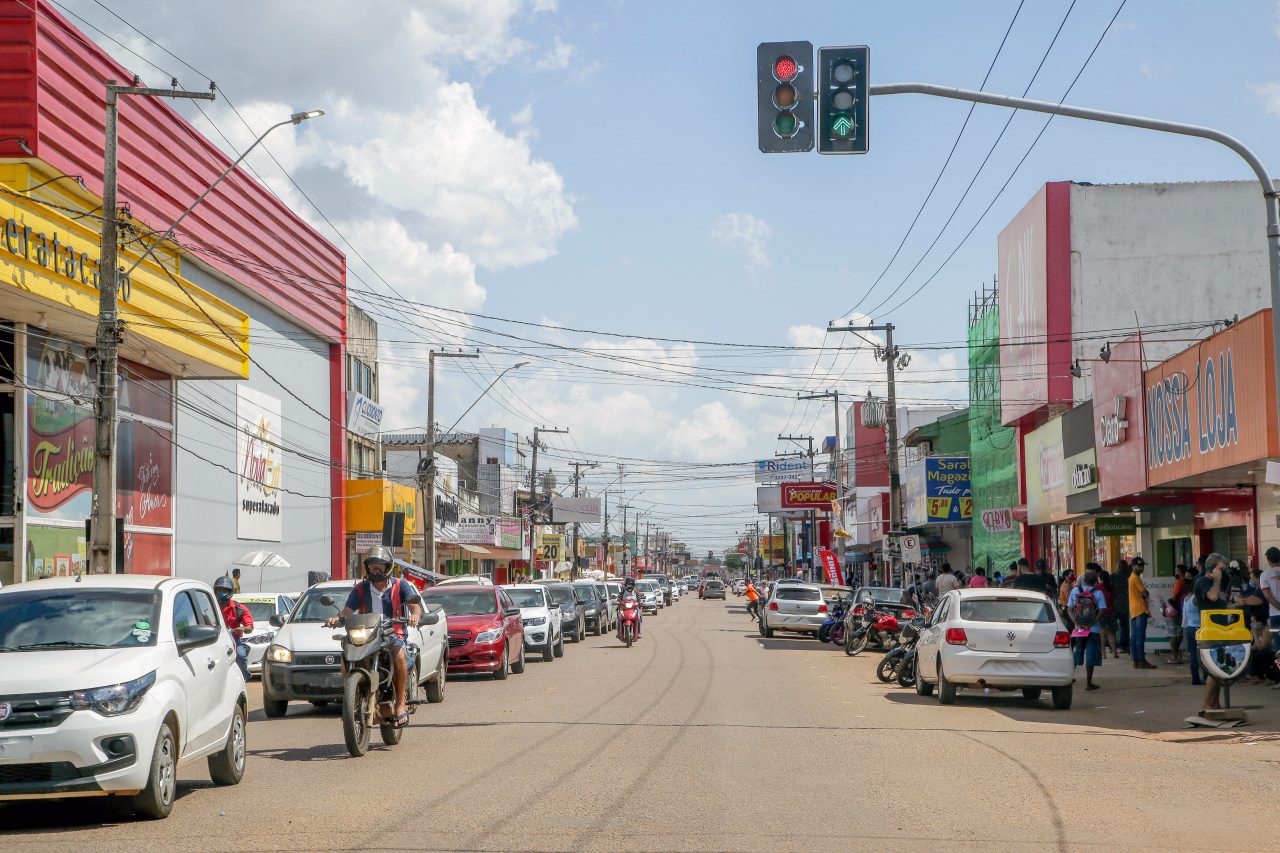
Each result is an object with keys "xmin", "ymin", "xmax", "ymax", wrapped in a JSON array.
[{"xmin": 915, "ymin": 588, "xmax": 1075, "ymax": 711}]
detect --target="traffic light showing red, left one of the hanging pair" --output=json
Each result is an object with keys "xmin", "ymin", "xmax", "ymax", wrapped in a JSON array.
[{"xmin": 755, "ymin": 41, "xmax": 813, "ymax": 154}]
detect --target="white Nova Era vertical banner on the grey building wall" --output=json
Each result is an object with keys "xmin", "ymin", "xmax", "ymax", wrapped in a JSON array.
[{"xmin": 236, "ymin": 386, "xmax": 284, "ymax": 542}]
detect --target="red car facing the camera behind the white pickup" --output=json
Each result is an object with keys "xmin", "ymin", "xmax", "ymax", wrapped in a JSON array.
[{"xmin": 422, "ymin": 587, "xmax": 525, "ymax": 679}]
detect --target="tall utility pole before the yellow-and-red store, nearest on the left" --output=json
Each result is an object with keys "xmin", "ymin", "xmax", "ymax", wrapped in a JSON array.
[{"xmin": 90, "ymin": 77, "xmax": 215, "ymax": 574}]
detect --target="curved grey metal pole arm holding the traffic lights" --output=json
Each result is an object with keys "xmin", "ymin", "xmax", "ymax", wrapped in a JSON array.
[{"xmin": 868, "ymin": 83, "xmax": 1280, "ymax": 458}]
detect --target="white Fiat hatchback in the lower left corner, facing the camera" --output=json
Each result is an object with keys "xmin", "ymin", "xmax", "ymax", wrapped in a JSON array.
[{"xmin": 0, "ymin": 575, "xmax": 248, "ymax": 818}]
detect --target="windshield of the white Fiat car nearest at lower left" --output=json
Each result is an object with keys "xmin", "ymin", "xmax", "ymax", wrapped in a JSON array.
[{"xmin": 0, "ymin": 588, "xmax": 160, "ymax": 652}]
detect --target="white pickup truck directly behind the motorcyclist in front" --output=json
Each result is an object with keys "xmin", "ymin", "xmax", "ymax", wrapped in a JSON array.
[{"xmin": 262, "ymin": 580, "xmax": 451, "ymax": 719}]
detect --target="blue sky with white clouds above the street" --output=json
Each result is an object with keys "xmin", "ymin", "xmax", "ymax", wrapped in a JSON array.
[{"xmin": 59, "ymin": 0, "xmax": 1280, "ymax": 551}]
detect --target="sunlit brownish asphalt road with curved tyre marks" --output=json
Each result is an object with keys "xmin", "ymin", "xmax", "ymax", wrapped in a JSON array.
[{"xmin": 0, "ymin": 597, "xmax": 1280, "ymax": 853}]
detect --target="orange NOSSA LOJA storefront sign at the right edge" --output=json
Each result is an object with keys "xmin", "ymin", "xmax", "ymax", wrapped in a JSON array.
[{"xmin": 1147, "ymin": 311, "xmax": 1280, "ymax": 485}]
